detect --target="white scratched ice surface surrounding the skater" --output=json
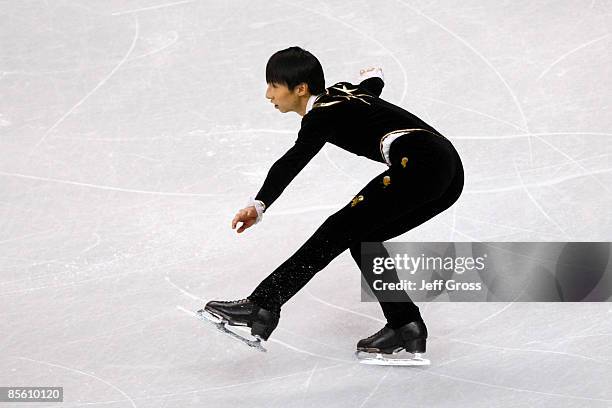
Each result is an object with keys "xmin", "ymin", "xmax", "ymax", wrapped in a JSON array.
[{"xmin": 0, "ymin": 0, "xmax": 612, "ymax": 408}]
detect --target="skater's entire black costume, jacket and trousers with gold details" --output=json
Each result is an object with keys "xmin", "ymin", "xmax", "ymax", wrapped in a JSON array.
[{"xmin": 249, "ymin": 77, "xmax": 463, "ymax": 328}]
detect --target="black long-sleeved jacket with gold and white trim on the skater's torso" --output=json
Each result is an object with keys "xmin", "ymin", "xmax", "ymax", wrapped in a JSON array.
[{"xmin": 255, "ymin": 77, "xmax": 438, "ymax": 210}]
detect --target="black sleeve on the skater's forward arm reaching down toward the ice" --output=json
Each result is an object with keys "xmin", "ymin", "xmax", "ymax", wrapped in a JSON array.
[{"xmin": 255, "ymin": 121, "xmax": 325, "ymax": 211}]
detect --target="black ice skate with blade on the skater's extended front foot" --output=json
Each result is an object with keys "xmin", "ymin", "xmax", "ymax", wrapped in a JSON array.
[{"xmin": 196, "ymin": 299, "xmax": 279, "ymax": 351}]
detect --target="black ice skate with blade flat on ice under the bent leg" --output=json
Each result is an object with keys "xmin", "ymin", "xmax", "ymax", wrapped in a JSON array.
[{"xmin": 355, "ymin": 320, "xmax": 430, "ymax": 365}]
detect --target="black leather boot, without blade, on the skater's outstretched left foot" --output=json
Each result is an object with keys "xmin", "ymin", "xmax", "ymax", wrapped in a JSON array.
[{"xmin": 198, "ymin": 299, "xmax": 279, "ymax": 340}]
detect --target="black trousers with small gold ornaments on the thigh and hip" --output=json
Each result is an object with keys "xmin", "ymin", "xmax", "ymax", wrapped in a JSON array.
[{"xmin": 249, "ymin": 131, "xmax": 463, "ymax": 328}]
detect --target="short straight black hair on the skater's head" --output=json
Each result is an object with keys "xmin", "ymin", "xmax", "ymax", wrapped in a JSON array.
[{"xmin": 266, "ymin": 47, "xmax": 325, "ymax": 95}]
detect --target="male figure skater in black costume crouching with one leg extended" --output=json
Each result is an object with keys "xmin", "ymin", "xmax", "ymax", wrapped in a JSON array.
[{"xmin": 200, "ymin": 47, "xmax": 463, "ymax": 354}]
